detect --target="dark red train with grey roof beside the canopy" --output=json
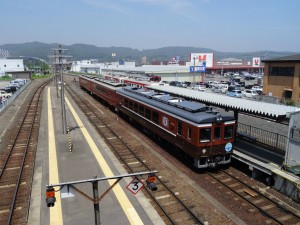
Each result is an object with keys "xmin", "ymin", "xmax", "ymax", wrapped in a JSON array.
[{"xmin": 79, "ymin": 75, "xmax": 236, "ymax": 168}]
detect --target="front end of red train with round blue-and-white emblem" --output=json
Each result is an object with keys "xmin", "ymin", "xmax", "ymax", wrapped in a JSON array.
[{"xmin": 194, "ymin": 121, "xmax": 235, "ymax": 168}]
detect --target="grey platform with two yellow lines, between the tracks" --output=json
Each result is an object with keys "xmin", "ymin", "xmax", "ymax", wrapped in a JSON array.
[{"xmin": 28, "ymin": 87, "xmax": 164, "ymax": 225}]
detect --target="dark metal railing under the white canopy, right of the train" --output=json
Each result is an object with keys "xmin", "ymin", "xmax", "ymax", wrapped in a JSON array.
[{"xmin": 238, "ymin": 123, "xmax": 287, "ymax": 151}]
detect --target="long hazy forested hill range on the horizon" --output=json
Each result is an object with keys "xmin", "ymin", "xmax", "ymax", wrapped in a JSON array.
[{"xmin": 0, "ymin": 42, "xmax": 297, "ymax": 62}]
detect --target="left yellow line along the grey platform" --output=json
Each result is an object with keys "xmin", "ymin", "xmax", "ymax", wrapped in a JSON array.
[{"xmin": 48, "ymin": 88, "xmax": 63, "ymax": 225}]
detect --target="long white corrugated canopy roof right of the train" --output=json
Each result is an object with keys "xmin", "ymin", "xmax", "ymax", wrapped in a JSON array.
[{"xmin": 148, "ymin": 86, "xmax": 300, "ymax": 118}]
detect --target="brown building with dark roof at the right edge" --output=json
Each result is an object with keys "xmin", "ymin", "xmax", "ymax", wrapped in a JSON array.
[{"xmin": 262, "ymin": 54, "xmax": 300, "ymax": 105}]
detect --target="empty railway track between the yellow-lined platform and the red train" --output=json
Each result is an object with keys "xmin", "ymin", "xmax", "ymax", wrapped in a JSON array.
[{"xmin": 67, "ymin": 84, "xmax": 204, "ymax": 225}]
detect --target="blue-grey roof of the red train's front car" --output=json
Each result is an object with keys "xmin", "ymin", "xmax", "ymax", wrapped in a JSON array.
[{"xmin": 117, "ymin": 86, "xmax": 234, "ymax": 124}]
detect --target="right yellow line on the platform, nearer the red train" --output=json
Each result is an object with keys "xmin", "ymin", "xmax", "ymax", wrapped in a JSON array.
[{"xmin": 65, "ymin": 97, "xmax": 144, "ymax": 224}]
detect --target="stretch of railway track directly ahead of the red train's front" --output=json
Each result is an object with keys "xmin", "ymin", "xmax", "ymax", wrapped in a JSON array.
[{"xmin": 207, "ymin": 170, "xmax": 300, "ymax": 225}]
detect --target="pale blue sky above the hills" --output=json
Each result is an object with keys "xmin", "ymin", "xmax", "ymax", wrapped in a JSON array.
[{"xmin": 0, "ymin": 0, "xmax": 300, "ymax": 52}]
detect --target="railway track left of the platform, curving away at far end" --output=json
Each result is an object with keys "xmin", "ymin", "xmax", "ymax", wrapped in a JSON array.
[{"xmin": 0, "ymin": 80, "xmax": 51, "ymax": 225}]
